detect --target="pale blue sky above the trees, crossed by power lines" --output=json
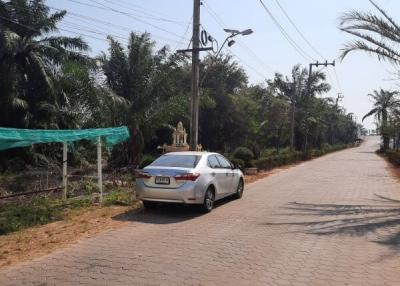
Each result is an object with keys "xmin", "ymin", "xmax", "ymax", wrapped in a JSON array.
[{"xmin": 47, "ymin": 0, "xmax": 400, "ymax": 128}]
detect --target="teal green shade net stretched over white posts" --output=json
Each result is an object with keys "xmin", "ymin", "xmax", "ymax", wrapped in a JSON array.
[{"xmin": 0, "ymin": 126, "xmax": 129, "ymax": 150}]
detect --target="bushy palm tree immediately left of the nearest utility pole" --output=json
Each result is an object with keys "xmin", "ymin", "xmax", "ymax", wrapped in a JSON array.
[{"xmin": 100, "ymin": 33, "xmax": 190, "ymax": 165}]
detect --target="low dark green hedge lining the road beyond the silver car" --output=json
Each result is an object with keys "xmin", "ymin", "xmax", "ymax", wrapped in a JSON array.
[{"xmin": 253, "ymin": 145, "xmax": 350, "ymax": 170}]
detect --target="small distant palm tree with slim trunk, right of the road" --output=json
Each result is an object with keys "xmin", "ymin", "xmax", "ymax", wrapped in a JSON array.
[{"xmin": 362, "ymin": 89, "xmax": 400, "ymax": 150}]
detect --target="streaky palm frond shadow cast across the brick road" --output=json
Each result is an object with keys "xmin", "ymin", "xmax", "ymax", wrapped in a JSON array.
[{"xmin": 266, "ymin": 195, "xmax": 400, "ymax": 251}]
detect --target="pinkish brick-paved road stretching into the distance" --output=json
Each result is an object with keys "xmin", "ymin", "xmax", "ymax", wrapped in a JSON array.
[{"xmin": 0, "ymin": 138, "xmax": 400, "ymax": 286}]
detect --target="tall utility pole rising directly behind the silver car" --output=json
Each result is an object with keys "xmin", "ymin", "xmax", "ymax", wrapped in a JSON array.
[{"xmin": 190, "ymin": 0, "xmax": 201, "ymax": 151}]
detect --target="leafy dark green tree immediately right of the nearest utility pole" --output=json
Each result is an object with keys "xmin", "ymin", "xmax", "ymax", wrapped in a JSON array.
[{"xmin": 199, "ymin": 55, "xmax": 251, "ymax": 151}]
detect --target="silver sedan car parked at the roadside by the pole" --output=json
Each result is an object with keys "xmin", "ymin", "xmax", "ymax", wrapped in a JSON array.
[{"xmin": 136, "ymin": 152, "xmax": 244, "ymax": 212}]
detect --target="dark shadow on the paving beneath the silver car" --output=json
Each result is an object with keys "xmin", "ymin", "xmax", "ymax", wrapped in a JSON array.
[{"xmin": 113, "ymin": 197, "xmax": 236, "ymax": 224}]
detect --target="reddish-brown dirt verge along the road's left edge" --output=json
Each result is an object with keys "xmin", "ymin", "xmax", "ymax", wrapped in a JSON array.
[{"xmin": 0, "ymin": 166, "xmax": 290, "ymax": 268}]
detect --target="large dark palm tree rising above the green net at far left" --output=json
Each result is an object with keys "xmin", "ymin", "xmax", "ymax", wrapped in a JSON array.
[{"xmin": 0, "ymin": 0, "xmax": 89, "ymax": 128}]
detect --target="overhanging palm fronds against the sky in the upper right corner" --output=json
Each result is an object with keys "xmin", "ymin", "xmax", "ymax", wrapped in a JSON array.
[{"xmin": 340, "ymin": 0, "xmax": 400, "ymax": 64}]
